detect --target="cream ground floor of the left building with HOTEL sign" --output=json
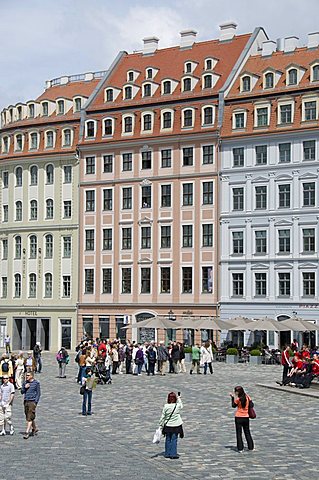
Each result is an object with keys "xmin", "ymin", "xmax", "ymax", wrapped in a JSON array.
[{"xmin": 0, "ymin": 308, "xmax": 76, "ymax": 351}]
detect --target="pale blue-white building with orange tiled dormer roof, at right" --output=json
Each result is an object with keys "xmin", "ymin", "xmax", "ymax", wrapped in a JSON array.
[{"xmin": 219, "ymin": 34, "xmax": 319, "ymax": 347}]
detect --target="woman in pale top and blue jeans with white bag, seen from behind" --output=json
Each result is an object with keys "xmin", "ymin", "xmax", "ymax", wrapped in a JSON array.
[{"xmin": 159, "ymin": 392, "xmax": 184, "ymax": 458}]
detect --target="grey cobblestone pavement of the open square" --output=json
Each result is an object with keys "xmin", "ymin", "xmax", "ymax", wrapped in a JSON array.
[{"xmin": 0, "ymin": 354, "xmax": 319, "ymax": 480}]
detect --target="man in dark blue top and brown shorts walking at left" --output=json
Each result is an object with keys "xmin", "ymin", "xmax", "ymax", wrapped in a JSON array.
[{"xmin": 21, "ymin": 372, "xmax": 41, "ymax": 439}]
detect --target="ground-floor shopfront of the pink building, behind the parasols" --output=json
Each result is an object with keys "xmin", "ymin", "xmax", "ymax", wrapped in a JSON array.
[{"xmin": 77, "ymin": 305, "xmax": 216, "ymax": 345}]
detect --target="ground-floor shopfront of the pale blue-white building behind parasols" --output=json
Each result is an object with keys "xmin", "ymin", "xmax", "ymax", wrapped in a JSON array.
[{"xmin": 220, "ymin": 302, "xmax": 319, "ymax": 349}]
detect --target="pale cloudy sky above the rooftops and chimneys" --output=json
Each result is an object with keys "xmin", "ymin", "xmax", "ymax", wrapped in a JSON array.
[{"xmin": 0, "ymin": 0, "xmax": 319, "ymax": 110}]
